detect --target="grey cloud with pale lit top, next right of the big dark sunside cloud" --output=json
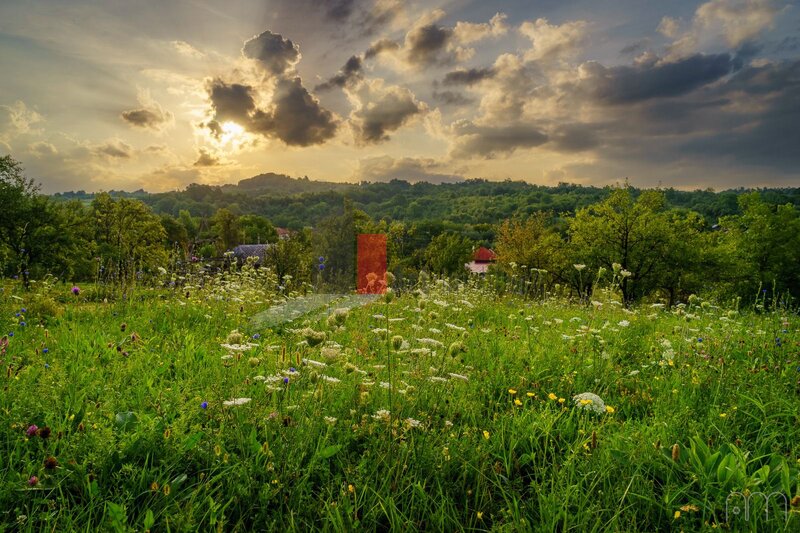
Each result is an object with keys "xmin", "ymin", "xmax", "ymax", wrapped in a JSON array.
[{"xmin": 351, "ymin": 83, "xmax": 422, "ymax": 144}]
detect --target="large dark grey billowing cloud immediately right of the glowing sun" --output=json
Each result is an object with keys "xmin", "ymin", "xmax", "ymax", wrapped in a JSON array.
[{"xmin": 251, "ymin": 78, "xmax": 337, "ymax": 146}]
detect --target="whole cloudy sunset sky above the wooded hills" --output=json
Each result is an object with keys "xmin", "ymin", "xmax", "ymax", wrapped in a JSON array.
[{"xmin": 0, "ymin": 0, "xmax": 800, "ymax": 193}]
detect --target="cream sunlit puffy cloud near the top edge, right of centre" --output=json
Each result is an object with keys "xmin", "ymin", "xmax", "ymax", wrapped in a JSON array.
[{"xmin": 519, "ymin": 18, "xmax": 588, "ymax": 61}]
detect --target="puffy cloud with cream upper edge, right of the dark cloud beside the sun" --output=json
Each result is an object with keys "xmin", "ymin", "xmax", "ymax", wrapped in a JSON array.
[{"xmin": 346, "ymin": 79, "xmax": 425, "ymax": 144}]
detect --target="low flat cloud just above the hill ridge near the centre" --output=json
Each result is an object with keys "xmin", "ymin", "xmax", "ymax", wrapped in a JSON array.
[{"xmin": 354, "ymin": 156, "xmax": 464, "ymax": 183}]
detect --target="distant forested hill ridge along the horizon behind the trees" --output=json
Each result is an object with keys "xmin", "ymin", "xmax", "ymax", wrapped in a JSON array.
[{"xmin": 55, "ymin": 173, "xmax": 800, "ymax": 229}]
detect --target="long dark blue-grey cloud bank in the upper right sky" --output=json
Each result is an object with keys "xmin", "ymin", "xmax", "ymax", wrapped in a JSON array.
[{"xmin": 582, "ymin": 54, "xmax": 734, "ymax": 104}]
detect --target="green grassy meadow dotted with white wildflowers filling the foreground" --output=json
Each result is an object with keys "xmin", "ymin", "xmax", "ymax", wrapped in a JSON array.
[{"xmin": 0, "ymin": 269, "xmax": 800, "ymax": 531}]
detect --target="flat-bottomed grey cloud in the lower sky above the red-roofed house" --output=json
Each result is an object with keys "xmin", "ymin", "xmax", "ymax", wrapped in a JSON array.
[{"xmin": 453, "ymin": 122, "xmax": 548, "ymax": 159}]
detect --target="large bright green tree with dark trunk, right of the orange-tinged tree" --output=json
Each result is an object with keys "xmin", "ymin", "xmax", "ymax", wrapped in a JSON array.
[{"xmin": 569, "ymin": 187, "xmax": 670, "ymax": 305}]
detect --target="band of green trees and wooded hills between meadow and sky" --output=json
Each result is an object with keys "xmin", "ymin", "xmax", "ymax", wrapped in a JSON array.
[{"xmin": 0, "ymin": 156, "xmax": 800, "ymax": 303}]
